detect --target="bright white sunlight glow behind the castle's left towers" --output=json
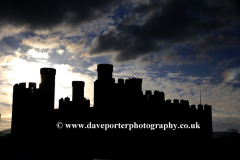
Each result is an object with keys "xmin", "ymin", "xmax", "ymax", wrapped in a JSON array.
[{"xmin": 0, "ymin": 55, "xmax": 93, "ymax": 112}]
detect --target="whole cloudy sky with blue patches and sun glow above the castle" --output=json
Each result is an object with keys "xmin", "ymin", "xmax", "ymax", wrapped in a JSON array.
[{"xmin": 0, "ymin": 0, "xmax": 240, "ymax": 131}]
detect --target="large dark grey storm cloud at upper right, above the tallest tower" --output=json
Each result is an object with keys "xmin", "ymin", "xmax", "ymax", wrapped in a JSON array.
[{"xmin": 90, "ymin": 0, "xmax": 240, "ymax": 62}]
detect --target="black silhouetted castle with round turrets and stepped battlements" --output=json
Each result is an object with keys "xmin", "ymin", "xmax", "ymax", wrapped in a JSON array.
[{"xmin": 11, "ymin": 64, "xmax": 212, "ymax": 156}]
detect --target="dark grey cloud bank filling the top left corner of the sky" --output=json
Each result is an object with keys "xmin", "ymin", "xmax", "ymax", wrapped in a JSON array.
[{"xmin": 0, "ymin": 0, "xmax": 119, "ymax": 30}]
